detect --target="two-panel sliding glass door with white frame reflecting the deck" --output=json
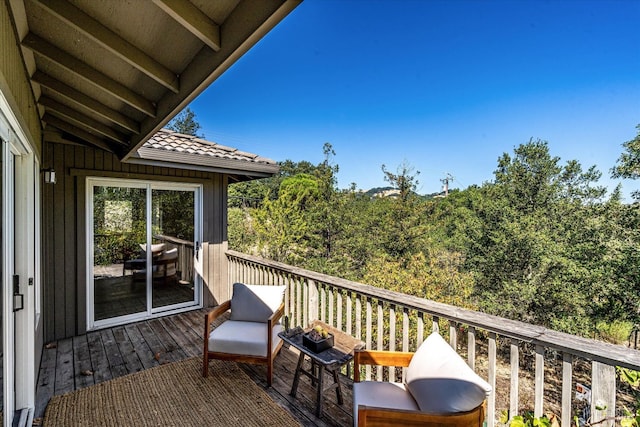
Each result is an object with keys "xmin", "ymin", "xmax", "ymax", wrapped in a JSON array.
[{"xmin": 87, "ymin": 179, "xmax": 201, "ymax": 328}]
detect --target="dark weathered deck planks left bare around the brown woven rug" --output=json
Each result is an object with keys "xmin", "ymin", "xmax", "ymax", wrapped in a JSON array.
[{"xmin": 35, "ymin": 310, "xmax": 353, "ymax": 426}]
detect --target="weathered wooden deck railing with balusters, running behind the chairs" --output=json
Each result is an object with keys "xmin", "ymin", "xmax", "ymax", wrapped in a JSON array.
[{"xmin": 227, "ymin": 250, "xmax": 640, "ymax": 427}]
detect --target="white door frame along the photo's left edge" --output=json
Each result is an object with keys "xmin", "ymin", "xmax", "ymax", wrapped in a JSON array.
[{"xmin": 0, "ymin": 92, "xmax": 40, "ymax": 426}]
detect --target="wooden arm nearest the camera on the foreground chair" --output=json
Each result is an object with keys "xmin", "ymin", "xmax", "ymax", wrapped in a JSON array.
[{"xmin": 358, "ymin": 401, "xmax": 486, "ymax": 427}]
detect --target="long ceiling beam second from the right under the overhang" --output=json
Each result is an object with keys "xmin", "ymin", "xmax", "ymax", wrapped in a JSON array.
[{"xmin": 40, "ymin": 0, "xmax": 180, "ymax": 93}]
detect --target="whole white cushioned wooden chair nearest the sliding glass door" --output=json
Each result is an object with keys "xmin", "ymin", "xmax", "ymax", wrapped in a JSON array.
[{"xmin": 202, "ymin": 283, "xmax": 286, "ymax": 386}]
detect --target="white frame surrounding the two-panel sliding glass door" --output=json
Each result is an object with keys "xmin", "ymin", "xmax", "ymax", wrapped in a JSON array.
[{"xmin": 85, "ymin": 177, "xmax": 203, "ymax": 330}]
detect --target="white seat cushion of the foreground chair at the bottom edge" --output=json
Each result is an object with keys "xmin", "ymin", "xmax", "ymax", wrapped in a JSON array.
[{"xmin": 353, "ymin": 381, "xmax": 419, "ymax": 426}]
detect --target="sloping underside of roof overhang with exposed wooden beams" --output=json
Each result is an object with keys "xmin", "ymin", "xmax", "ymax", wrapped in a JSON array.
[{"xmin": 9, "ymin": 0, "xmax": 302, "ymax": 160}]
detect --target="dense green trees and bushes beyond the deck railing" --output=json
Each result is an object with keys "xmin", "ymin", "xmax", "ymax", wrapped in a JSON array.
[{"xmin": 229, "ymin": 137, "xmax": 640, "ymax": 342}]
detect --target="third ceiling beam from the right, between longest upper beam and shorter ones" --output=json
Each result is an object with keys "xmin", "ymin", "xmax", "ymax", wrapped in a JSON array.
[{"xmin": 22, "ymin": 33, "xmax": 156, "ymax": 118}]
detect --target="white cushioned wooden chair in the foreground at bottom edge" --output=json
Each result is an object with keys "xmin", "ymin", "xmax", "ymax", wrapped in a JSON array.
[{"xmin": 353, "ymin": 332, "xmax": 492, "ymax": 427}]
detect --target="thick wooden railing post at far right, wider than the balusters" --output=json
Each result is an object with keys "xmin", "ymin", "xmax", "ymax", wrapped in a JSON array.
[{"xmin": 591, "ymin": 361, "xmax": 616, "ymax": 427}]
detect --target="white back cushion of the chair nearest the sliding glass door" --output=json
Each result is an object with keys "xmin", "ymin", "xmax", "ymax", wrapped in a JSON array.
[{"xmin": 231, "ymin": 283, "xmax": 287, "ymax": 323}]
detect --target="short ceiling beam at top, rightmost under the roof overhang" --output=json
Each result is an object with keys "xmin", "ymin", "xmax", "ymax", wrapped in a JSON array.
[{"xmin": 153, "ymin": 0, "xmax": 220, "ymax": 52}]
